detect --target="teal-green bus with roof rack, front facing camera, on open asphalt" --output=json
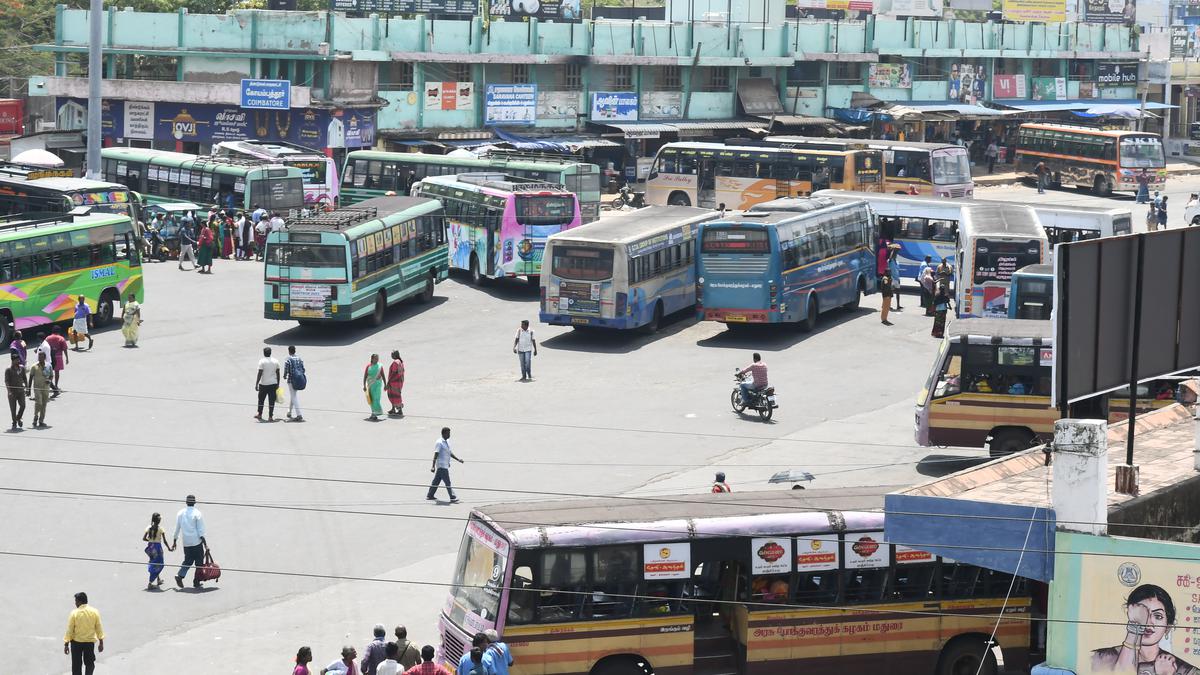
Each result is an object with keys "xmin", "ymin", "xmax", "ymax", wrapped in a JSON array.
[{"xmin": 263, "ymin": 197, "xmax": 450, "ymax": 325}]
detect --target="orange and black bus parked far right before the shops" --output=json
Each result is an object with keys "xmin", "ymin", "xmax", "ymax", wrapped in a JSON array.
[{"xmin": 1016, "ymin": 124, "xmax": 1166, "ymax": 196}]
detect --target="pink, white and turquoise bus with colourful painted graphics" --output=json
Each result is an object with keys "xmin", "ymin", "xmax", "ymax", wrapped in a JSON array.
[{"xmin": 413, "ymin": 173, "xmax": 581, "ymax": 285}]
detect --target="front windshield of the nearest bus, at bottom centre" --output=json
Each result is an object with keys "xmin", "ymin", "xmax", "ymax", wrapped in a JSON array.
[{"xmin": 450, "ymin": 520, "xmax": 509, "ymax": 629}]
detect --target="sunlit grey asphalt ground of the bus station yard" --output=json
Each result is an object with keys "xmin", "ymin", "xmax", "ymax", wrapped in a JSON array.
[{"xmin": 0, "ymin": 174, "xmax": 1185, "ymax": 675}]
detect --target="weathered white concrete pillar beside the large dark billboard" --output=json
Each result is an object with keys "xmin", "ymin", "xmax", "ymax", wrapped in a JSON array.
[{"xmin": 1052, "ymin": 419, "xmax": 1109, "ymax": 536}]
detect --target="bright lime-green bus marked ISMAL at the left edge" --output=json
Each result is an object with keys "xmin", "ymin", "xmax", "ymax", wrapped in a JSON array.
[{"xmin": 0, "ymin": 213, "xmax": 144, "ymax": 346}]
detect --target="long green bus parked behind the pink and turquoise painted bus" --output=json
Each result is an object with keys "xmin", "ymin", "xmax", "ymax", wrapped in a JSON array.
[{"xmin": 342, "ymin": 150, "xmax": 600, "ymax": 222}]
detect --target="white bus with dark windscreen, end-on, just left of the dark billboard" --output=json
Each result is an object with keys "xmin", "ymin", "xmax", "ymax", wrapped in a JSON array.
[{"xmin": 954, "ymin": 203, "xmax": 1050, "ymax": 318}]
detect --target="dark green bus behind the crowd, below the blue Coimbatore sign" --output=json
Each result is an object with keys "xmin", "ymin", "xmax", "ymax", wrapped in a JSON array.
[{"xmin": 100, "ymin": 148, "xmax": 304, "ymax": 213}]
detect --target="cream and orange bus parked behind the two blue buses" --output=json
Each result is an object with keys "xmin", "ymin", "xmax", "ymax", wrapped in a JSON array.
[{"xmin": 646, "ymin": 143, "xmax": 883, "ymax": 210}]
